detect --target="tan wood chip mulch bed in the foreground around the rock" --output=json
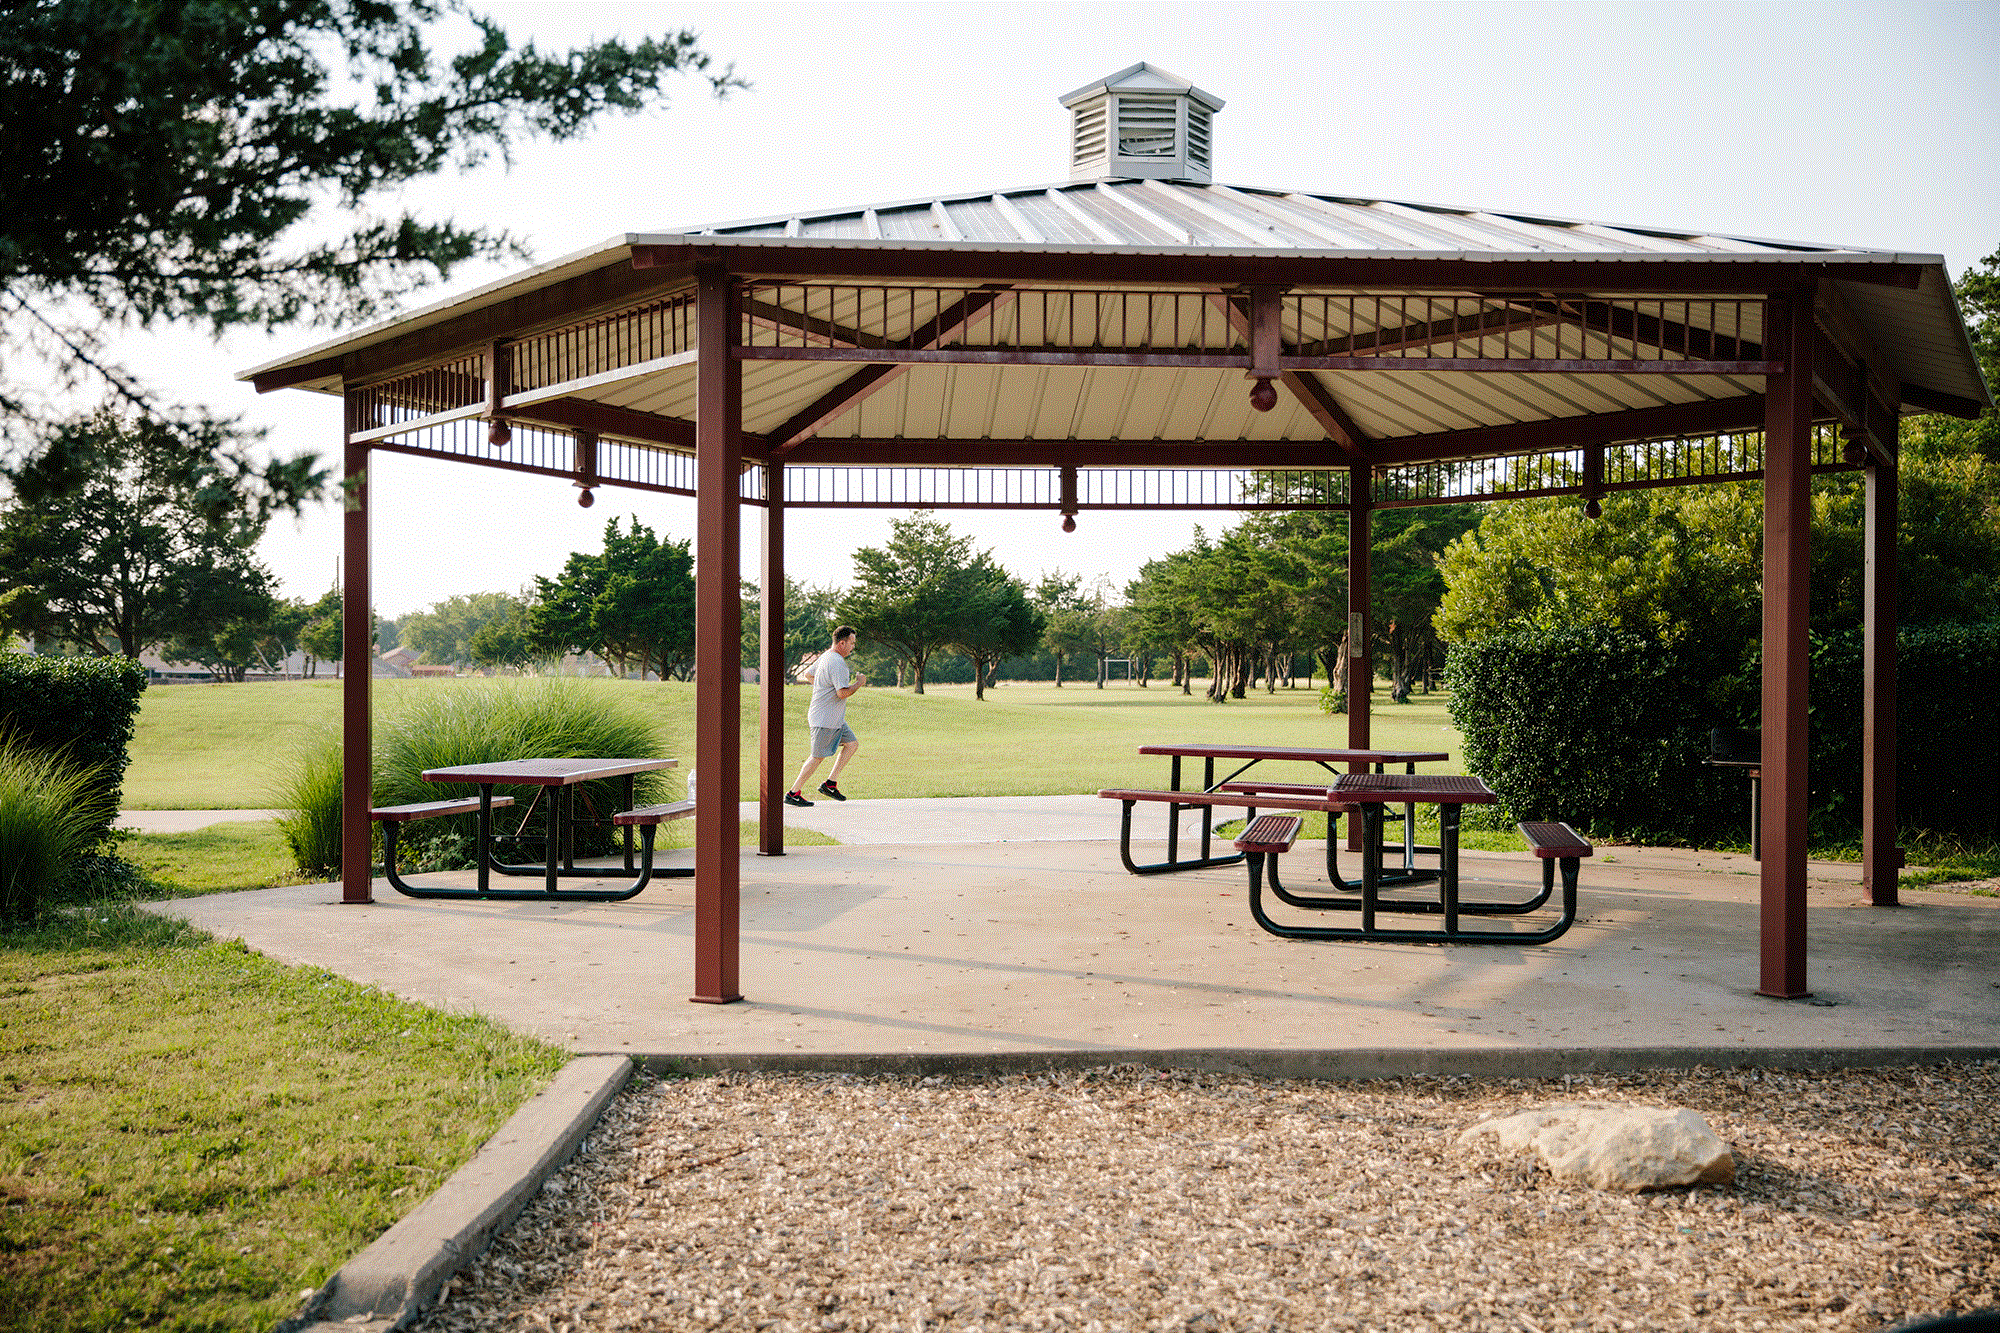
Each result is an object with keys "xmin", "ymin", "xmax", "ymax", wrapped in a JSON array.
[{"xmin": 416, "ymin": 1063, "xmax": 2000, "ymax": 1333}]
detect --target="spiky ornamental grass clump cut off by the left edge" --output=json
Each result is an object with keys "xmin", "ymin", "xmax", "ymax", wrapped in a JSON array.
[{"xmin": 0, "ymin": 737, "xmax": 108, "ymax": 923}]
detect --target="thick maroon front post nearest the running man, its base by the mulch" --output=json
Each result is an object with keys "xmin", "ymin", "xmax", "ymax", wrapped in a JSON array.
[{"xmin": 690, "ymin": 266, "xmax": 742, "ymax": 1005}]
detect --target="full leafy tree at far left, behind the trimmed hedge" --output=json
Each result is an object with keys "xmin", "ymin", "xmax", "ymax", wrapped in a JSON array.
[{"xmin": 0, "ymin": 412, "xmax": 280, "ymax": 656}]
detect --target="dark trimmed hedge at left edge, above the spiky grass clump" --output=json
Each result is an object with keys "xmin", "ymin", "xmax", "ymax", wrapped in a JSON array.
[{"xmin": 0, "ymin": 652, "xmax": 146, "ymax": 837}]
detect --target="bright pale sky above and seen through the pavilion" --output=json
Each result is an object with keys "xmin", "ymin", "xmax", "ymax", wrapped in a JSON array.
[{"xmin": 113, "ymin": 0, "xmax": 2000, "ymax": 616}]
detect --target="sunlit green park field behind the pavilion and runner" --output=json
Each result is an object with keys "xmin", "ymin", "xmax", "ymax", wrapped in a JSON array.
[{"xmin": 124, "ymin": 681, "xmax": 1460, "ymax": 811}]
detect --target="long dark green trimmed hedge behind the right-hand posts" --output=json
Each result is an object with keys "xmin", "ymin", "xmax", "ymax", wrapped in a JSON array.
[{"xmin": 1446, "ymin": 624, "xmax": 2000, "ymax": 843}]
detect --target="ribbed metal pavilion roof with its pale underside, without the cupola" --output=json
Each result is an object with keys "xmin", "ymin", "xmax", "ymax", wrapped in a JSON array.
[{"xmin": 242, "ymin": 178, "xmax": 1990, "ymax": 440}]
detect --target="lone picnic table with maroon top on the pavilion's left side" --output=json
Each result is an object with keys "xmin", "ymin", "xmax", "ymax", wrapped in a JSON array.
[{"xmin": 382, "ymin": 759, "xmax": 694, "ymax": 903}]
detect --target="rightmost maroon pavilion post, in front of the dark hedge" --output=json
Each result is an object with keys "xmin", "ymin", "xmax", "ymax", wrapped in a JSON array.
[{"xmin": 1862, "ymin": 458, "xmax": 1902, "ymax": 907}]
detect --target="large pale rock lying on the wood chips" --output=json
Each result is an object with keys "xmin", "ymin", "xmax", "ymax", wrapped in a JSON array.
[{"xmin": 1458, "ymin": 1103, "xmax": 1736, "ymax": 1191}]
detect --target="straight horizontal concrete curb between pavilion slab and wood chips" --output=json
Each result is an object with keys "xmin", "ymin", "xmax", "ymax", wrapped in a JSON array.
[{"xmin": 642, "ymin": 1047, "xmax": 2000, "ymax": 1079}]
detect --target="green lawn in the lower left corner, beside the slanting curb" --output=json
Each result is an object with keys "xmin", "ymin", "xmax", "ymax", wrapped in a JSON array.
[{"xmin": 0, "ymin": 907, "xmax": 566, "ymax": 1333}]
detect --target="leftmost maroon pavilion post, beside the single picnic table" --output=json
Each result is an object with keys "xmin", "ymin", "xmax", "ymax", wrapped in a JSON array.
[{"xmin": 340, "ymin": 412, "xmax": 374, "ymax": 903}]
